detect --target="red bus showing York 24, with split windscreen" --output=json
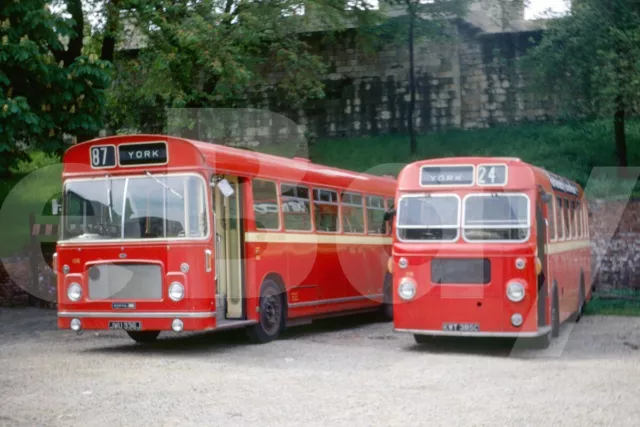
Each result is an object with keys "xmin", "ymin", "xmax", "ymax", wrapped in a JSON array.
[{"xmin": 392, "ymin": 157, "xmax": 592, "ymax": 347}]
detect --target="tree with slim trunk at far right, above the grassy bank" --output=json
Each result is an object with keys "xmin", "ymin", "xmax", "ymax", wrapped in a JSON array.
[{"xmin": 523, "ymin": 0, "xmax": 640, "ymax": 167}]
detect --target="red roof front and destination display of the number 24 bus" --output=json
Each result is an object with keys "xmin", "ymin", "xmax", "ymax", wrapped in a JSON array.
[{"xmin": 398, "ymin": 156, "xmax": 583, "ymax": 197}]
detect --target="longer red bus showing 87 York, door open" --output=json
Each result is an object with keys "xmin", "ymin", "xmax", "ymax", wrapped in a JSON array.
[{"xmin": 55, "ymin": 135, "xmax": 396, "ymax": 342}]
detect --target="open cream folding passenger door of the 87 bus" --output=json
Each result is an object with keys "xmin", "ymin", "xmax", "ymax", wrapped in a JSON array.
[{"xmin": 215, "ymin": 176, "xmax": 244, "ymax": 319}]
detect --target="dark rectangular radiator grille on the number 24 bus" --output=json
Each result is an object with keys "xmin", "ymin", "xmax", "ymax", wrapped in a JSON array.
[{"xmin": 431, "ymin": 258, "xmax": 491, "ymax": 285}]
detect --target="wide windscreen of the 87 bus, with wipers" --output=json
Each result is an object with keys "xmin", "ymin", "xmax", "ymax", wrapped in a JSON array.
[{"xmin": 61, "ymin": 175, "xmax": 208, "ymax": 241}]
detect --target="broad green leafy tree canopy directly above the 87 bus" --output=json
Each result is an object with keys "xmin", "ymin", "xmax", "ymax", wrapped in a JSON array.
[{"xmin": 111, "ymin": 0, "xmax": 382, "ymax": 137}]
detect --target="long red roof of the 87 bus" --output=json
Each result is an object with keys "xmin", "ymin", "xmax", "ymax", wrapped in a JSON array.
[{"xmin": 63, "ymin": 134, "xmax": 396, "ymax": 195}]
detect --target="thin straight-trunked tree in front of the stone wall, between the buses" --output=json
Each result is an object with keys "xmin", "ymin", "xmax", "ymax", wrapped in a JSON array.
[{"xmin": 381, "ymin": 0, "xmax": 470, "ymax": 155}]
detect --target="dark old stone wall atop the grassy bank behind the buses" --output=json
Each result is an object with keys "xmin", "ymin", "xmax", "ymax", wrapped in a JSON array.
[{"xmin": 251, "ymin": 23, "xmax": 553, "ymax": 142}]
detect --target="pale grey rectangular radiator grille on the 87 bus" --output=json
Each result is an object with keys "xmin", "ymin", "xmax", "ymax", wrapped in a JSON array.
[{"xmin": 88, "ymin": 264, "xmax": 162, "ymax": 300}]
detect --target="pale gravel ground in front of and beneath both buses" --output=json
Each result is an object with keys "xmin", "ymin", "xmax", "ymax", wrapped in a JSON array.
[{"xmin": 0, "ymin": 309, "xmax": 640, "ymax": 427}]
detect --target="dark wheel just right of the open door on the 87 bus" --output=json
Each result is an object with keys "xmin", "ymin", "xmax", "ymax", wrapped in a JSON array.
[{"xmin": 247, "ymin": 280, "xmax": 285, "ymax": 343}]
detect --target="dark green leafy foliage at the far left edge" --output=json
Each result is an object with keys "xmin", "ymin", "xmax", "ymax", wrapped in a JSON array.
[{"xmin": 0, "ymin": 0, "xmax": 110, "ymax": 175}]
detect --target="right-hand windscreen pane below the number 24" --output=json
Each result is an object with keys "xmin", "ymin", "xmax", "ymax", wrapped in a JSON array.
[{"xmin": 463, "ymin": 193, "xmax": 531, "ymax": 241}]
